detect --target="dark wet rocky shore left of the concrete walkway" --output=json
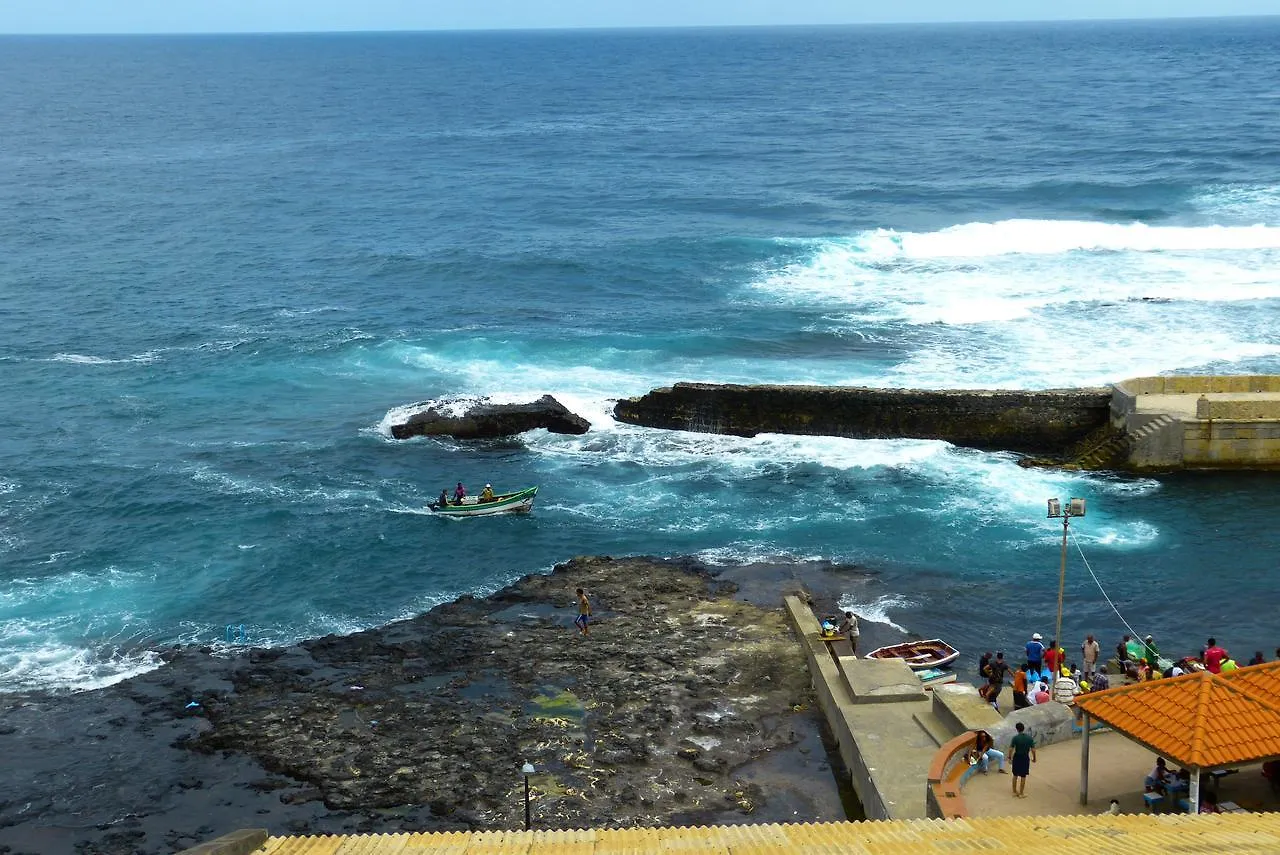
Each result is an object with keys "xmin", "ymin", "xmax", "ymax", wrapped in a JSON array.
[{"xmin": 0, "ymin": 558, "xmax": 870, "ymax": 855}]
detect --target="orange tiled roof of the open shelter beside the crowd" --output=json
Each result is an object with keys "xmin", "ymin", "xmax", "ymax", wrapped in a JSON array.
[{"xmin": 1075, "ymin": 663, "xmax": 1280, "ymax": 769}]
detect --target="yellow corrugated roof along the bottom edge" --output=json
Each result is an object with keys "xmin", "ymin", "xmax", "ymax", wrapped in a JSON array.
[{"xmin": 260, "ymin": 813, "xmax": 1280, "ymax": 855}]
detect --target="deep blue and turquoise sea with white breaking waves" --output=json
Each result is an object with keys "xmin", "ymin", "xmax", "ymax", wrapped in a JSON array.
[{"xmin": 0, "ymin": 19, "xmax": 1280, "ymax": 690}]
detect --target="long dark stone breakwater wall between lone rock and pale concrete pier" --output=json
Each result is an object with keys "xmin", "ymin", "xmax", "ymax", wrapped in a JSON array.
[{"xmin": 613, "ymin": 383, "xmax": 1111, "ymax": 454}]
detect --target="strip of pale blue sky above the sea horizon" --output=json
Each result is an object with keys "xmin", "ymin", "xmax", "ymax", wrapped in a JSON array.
[{"xmin": 0, "ymin": 0, "xmax": 1280, "ymax": 33}]
